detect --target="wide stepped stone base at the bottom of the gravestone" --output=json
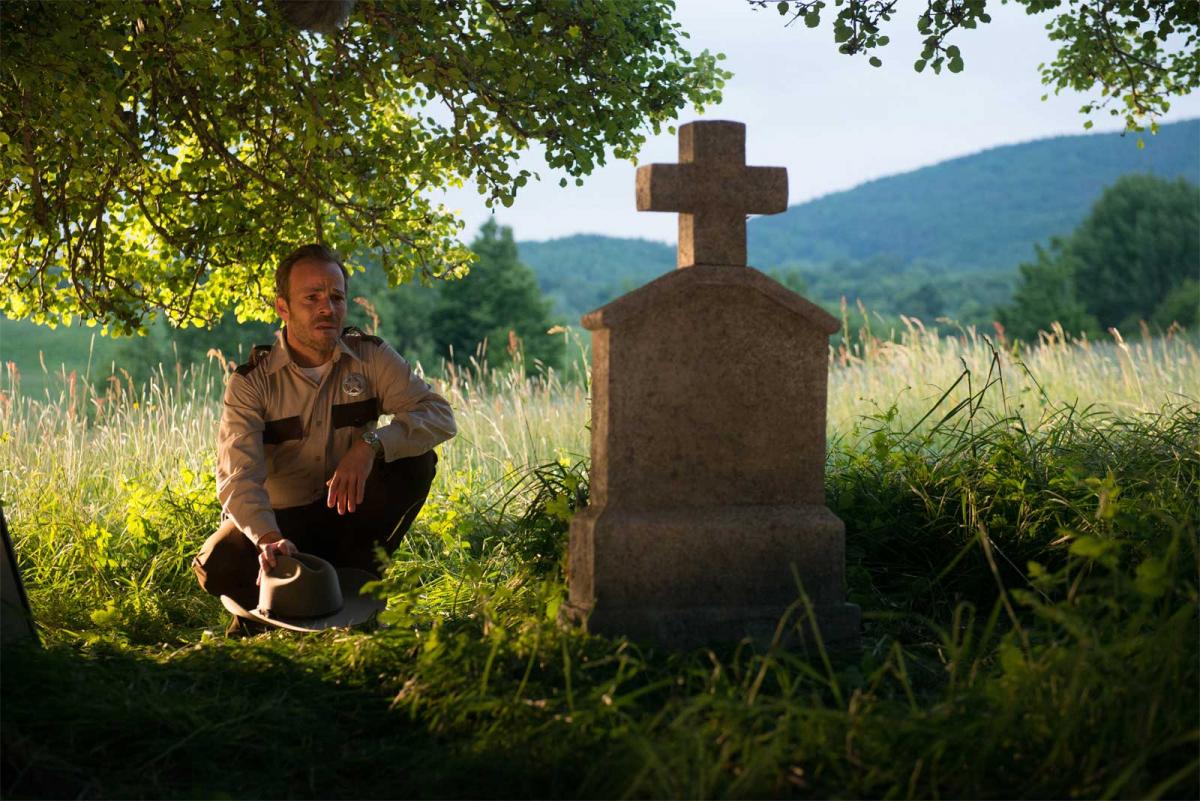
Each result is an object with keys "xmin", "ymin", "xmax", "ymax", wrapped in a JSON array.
[{"xmin": 563, "ymin": 506, "xmax": 859, "ymax": 650}]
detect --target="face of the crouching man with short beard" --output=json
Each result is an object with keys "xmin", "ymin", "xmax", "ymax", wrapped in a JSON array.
[{"xmin": 275, "ymin": 260, "xmax": 346, "ymax": 355}]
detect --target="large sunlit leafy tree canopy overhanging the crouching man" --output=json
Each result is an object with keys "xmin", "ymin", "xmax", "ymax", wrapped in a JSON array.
[{"xmin": 0, "ymin": 0, "xmax": 728, "ymax": 332}]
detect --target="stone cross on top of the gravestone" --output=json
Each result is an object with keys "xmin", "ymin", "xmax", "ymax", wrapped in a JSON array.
[{"xmin": 637, "ymin": 121, "xmax": 787, "ymax": 267}]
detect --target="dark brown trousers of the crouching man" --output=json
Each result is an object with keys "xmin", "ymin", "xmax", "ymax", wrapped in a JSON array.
[{"xmin": 192, "ymin": 451, "xmax": 438, "ymax": 609}]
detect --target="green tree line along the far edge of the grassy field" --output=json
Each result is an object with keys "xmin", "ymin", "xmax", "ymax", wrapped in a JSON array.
[{"xmin": 98, "ymin": 169, "xmax": 1200, "ymax": 381}]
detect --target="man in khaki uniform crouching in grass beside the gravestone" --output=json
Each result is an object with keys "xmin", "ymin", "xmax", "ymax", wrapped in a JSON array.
[{"xmin": 192, "ymin": 245, "xmax": 456, "ymax": 633}]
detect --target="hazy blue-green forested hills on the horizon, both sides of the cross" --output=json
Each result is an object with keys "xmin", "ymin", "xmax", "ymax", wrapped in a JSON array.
[{"xmin": 517, "ymin": 120, "xmax": 1200, "ymax": 318}]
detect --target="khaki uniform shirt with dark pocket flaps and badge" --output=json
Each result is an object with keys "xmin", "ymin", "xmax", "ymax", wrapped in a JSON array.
[{"xmin": 217, "ymin": 329, "xmax": 456, "ymax": 543}]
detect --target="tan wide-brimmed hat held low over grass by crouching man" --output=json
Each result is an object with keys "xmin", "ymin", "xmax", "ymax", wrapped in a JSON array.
[{"xmin": 221, "ymin": 554, "xmax": 386, "ymax": 632}]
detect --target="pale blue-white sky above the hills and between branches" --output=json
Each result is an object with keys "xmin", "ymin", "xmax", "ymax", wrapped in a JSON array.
[{"xmin": 444, "ymin": 0, "xmax": 1200, "ymax": 242}]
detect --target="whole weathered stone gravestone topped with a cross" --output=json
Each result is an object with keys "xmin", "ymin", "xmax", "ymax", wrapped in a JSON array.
[{"xmin": 564, "ymin": 121, "xmax": 859, "ymax": 648}]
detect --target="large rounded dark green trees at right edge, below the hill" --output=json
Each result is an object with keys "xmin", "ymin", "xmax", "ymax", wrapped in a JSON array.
[{"xmin": 997, "ymin": 175, "xmax": 1200, "ymax": 339}]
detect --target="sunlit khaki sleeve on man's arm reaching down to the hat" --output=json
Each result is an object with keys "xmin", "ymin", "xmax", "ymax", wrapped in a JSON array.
[{"xmin": 217, "ymin": 373, "xmax": 278, "ymax": 544}]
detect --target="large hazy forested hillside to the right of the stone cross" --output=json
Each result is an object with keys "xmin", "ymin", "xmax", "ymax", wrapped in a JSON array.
[{"xmin": 748, "ymin": 120, "xmax": 1200, "ymax": 269}]
